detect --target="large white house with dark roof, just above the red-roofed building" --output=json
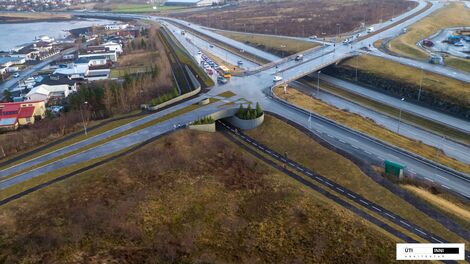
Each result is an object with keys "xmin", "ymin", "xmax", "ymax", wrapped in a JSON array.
[{"xmin": 25, "ymin": 75, "xmax": 77, "ymax": 103}]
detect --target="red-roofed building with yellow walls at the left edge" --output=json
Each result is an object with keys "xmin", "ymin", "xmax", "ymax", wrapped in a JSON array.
[{"xmin": 0, "ymin": 101, "xmax": 46, "ymax": 130}]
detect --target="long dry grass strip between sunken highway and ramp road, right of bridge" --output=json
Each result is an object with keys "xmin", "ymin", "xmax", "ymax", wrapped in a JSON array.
[{"xmin": 275, "ymin": 87, "xmax": 470, "ymax": 179}]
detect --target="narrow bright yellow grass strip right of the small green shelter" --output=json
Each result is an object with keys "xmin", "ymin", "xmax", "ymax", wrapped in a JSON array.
[{"xmin": 402, "ymin": 185, "xmax": 470, "ymax": 223}]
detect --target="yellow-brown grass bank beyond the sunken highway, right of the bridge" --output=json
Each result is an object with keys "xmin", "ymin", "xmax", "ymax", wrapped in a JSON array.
[{"xmin": 342, "ymin": 56, "xmax": 470, "ymax": 107}]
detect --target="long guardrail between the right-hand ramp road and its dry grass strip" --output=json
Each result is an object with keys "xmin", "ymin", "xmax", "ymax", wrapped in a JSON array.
[{"xmin": 269, "ymin": 85, "xmax": 470, "ymax": 190}]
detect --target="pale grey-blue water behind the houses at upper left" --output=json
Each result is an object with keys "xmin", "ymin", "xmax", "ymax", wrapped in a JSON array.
[{"xmin": 0, "ymin": 19, "xmax": 113, "ymax": 51}]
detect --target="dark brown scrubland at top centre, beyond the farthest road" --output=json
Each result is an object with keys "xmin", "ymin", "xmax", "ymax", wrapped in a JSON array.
[{"xmin": 173, "ymin": 0, "xmax": 416, "ymax": 37}]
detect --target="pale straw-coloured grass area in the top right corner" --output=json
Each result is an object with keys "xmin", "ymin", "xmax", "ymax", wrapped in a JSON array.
[{"xmin": 389, "ymin": 3, "xmax": 470, "ymax": 71}]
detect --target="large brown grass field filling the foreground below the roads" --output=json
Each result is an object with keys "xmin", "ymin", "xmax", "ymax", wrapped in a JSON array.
[{"xmin": 0, "ymin": 127, "xmax": 408, "ymax": 263}]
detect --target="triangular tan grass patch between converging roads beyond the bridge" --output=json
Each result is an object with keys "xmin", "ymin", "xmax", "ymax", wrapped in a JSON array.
[{"xmin": 216, "ymin": 30, "xmax": 320, "ymax": 57}]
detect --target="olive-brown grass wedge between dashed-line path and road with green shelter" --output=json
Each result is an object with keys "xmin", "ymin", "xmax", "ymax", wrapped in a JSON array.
[{"xmin": 247, "ymin": 115, "xmax": 464, "ymax": 244}]
